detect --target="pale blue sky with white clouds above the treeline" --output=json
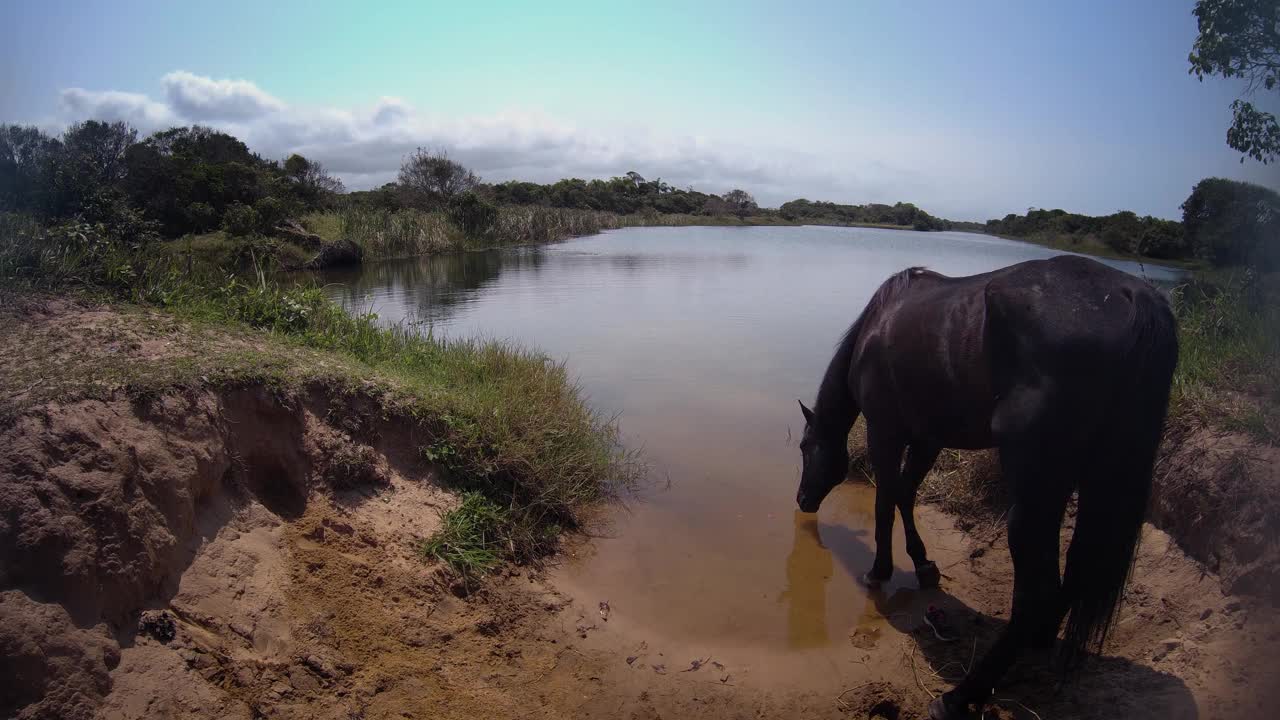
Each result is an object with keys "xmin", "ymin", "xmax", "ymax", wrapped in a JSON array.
[{"xmin": 0, "ymin": 0, "xmax": 1280, "ymax": 220}]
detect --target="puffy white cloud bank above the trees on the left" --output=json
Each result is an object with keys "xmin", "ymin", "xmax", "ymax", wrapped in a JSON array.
[{"xmin": 55, "ymin": 72, "xmax": 870, "ymax": 204}]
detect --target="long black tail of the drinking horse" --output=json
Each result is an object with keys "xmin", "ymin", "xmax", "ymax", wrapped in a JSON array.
[{"xmin": 1060, "ymin": 285, "xmax": 1178, "ymax": 671}]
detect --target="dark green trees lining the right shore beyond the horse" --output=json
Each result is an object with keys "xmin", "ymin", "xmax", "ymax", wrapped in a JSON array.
[{"xmin": 986, "ymin": 178, "xmax": 1280, "ymax": 269}]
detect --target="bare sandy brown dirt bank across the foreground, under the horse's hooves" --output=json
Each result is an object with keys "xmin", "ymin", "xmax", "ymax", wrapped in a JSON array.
[{"xmin": 0, "ymin": 298, "xmax": 1280, "ymax": 719}]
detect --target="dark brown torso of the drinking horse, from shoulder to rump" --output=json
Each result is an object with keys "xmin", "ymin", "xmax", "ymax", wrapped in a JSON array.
[{"xmin": 849, "ymin": 256, "xmax": 1172, "ymax": 448}]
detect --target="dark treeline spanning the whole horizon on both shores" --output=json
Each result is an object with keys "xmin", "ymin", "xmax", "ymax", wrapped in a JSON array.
[{"xmin": 0, "ymin": 120, "xmax": 1280, "ymax": 268}]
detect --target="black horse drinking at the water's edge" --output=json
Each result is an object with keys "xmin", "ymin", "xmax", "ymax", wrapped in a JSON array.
[{"xmin": 796, "ymin": 256, "xmax": 1178, "ymax": 719}]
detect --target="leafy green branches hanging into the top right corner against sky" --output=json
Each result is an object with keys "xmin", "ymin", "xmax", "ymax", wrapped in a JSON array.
[{"xmin": 1188, "ymin": 0, "xmax": 1280, "ymax": 163}]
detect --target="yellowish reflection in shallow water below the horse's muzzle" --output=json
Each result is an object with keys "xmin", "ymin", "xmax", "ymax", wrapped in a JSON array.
[{"xmin": 778, "ymin": 510, "xmax": 835, "ymax": 650}]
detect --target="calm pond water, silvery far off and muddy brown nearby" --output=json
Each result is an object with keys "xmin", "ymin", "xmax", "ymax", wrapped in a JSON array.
[{"xmin": 323, "ymin": 227, "xmax": 1178, "ymax": 652}]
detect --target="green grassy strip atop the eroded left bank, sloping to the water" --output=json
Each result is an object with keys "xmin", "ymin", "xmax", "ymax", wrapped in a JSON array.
[{"xmin": 0, "ymin": 210, "xmax": 639, "ymax": 571}]
